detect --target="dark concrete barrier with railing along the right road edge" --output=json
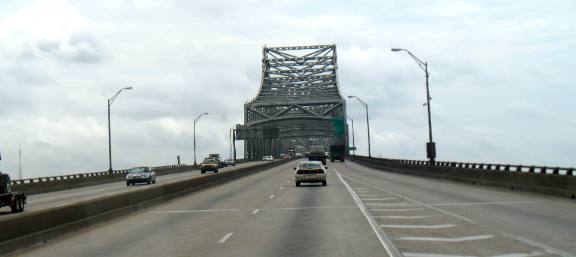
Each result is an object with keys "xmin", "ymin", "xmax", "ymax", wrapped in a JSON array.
[{"xmin": 350, "ymin": 156, "xmax": 576, "ymax": 199}]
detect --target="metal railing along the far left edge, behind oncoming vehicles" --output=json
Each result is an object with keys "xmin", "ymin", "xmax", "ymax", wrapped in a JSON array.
[{"xmin": 10, "ymin": 159, "xmax": 246, "ymax": 185}]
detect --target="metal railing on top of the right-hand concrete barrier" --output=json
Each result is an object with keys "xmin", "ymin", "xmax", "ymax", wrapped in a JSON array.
[{"xmin": 350, "ymin": 155, "xmax": 574, "ymax": 176}]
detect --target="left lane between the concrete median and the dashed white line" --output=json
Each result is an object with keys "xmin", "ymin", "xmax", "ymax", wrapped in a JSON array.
[{"xmin": 12, "ymin": 159, "xmax": 302, "ymax": 256}]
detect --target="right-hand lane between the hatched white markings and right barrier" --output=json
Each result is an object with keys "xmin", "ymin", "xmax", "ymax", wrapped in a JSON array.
[{"xmin": 337, "ymin": 162, "xmax": 576, "ymax": 256}]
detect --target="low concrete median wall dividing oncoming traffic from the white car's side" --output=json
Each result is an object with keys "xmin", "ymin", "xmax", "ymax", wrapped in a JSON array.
[{"xmin": 0, "ymin": 160, "xmax": 288, "ymax": 253}]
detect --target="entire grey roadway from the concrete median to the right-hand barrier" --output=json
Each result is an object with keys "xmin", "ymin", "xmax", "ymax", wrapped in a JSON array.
[{"xmin": 10, "ymin": 159, "xmax": 576, "ymax": 257}]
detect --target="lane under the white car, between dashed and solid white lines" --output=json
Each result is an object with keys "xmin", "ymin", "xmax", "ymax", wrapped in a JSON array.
[{"xmin": 223, "ymin": 164, "xmax": 387, "ymax": 257}]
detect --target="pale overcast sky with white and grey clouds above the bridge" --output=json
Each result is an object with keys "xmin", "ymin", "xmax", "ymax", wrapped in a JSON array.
[{"xmin": 0, "ymin": 0, "xmax": 576, "ymax": 177}]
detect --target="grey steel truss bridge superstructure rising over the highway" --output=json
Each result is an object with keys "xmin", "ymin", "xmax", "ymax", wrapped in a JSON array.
[{"xmin": 236, "ymin": 45, "xmax": 348, "ymax": 159}]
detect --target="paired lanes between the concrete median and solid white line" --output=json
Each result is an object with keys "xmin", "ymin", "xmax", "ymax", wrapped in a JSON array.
[{"xmin": 18, "ymin": 162, "xmax": 386, "ymax": 256}]
